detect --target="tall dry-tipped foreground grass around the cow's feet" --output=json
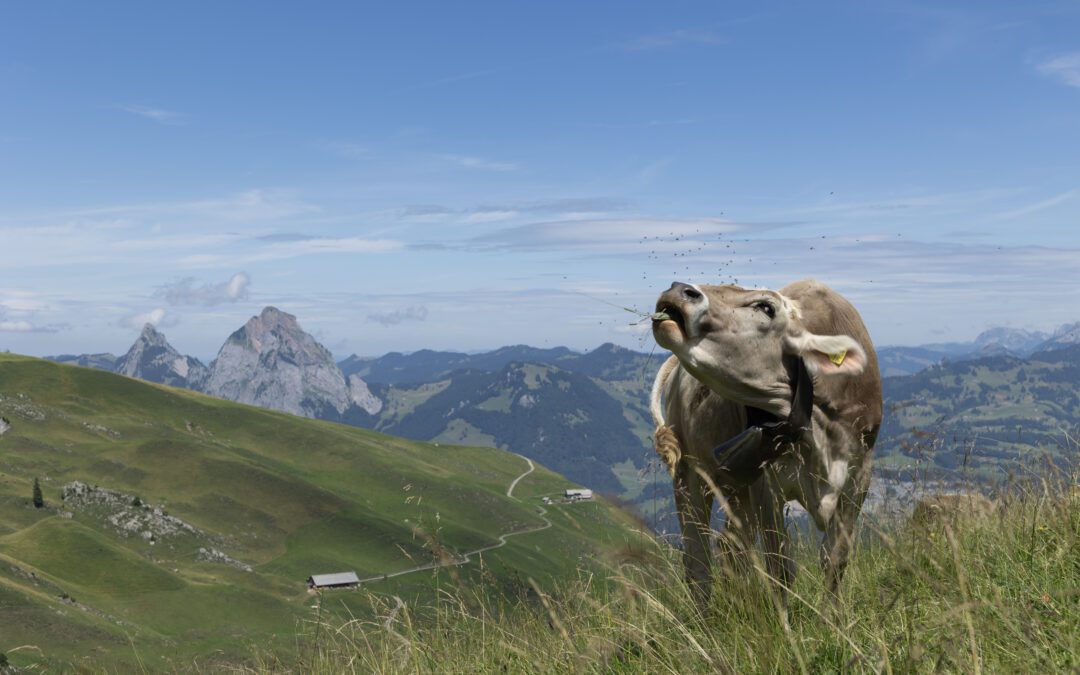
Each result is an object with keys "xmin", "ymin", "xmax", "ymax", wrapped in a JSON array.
[{"xmin": 263, "ymin": 474, "xmax": 1080, "ymax": 673}]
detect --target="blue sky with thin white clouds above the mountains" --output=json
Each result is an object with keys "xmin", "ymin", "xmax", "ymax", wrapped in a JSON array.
[{"xmin": 0, "ymin": 1, "xmax": 1080, "ymax": 359}]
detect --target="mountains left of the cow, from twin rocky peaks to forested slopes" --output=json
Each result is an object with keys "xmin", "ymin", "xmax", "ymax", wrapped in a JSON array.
[{"xmin": 49, "ymin": 317, "xmax": 661, "ymax": 495}]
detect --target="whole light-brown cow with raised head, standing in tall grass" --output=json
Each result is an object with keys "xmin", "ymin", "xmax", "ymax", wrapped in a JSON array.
[{"xmin": 650, "ymin": 280, "xmax": 882, "ymax": 607}]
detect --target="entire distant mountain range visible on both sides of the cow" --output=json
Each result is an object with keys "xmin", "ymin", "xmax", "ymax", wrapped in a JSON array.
[{"xmin": 44, "ymin": 308, "xmax": 1080, "ymax": 512}]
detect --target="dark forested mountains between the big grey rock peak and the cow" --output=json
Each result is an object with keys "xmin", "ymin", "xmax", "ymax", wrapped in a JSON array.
[{"xmin": 367, "ymin": 345, "xmax": 670, "ymax": 505}]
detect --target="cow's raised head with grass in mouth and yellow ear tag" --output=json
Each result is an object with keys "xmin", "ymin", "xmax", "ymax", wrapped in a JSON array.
[{"xmin": 652, "ymin": 282, "xmax": 866, "ymax": 417}]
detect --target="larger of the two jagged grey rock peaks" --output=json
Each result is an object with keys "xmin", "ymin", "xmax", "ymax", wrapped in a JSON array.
[{"xmin": 203, "ymin": 307, "xmax": 382, "ymax": 420}]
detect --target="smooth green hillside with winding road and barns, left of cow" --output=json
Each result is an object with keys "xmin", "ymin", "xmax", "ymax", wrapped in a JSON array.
[{"xmin": 0, "ymin": 354, "xmax": 640, "ymax": 671}]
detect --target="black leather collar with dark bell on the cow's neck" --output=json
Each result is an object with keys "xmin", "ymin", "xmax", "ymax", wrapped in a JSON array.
[{"xmin": 713, "ymin": 357, "xmax": 813, "ymax": 487}]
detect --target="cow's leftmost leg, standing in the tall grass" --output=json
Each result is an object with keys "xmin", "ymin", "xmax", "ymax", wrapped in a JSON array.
[{"xmin": 674, "ymin": 457, "xmax": 713, "ymax": 609}]
